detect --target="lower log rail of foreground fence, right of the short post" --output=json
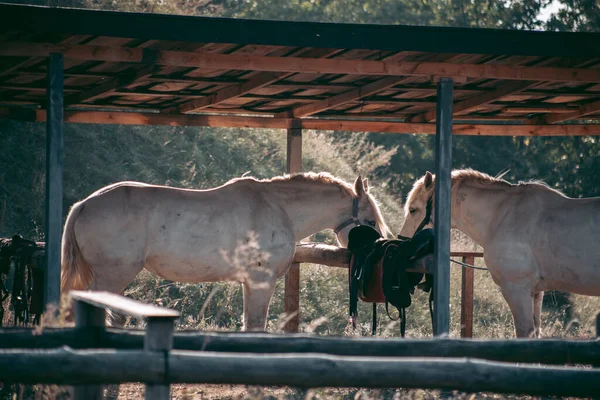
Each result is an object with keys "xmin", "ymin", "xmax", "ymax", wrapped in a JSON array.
[{"xmin": 170, "ymin": 351, "xmax": 600, "ymax": 397}]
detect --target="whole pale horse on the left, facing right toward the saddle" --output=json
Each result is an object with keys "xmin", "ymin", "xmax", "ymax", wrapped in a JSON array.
[{"xmin": 61, "ymin": 173, "xmax": 389, "ymax": 330}]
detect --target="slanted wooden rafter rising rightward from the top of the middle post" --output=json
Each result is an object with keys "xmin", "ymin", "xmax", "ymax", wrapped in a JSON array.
[{"xmin": 292, "ymin": 77, "xmax": 404, "ymax": 118}]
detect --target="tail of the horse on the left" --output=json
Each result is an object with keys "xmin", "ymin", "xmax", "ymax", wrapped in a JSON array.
[{"xmin": 60, "ymin": 202, "xmax": 94, "ymax": 293}]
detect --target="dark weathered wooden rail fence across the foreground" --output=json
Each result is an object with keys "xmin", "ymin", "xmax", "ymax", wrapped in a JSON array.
[{"xmin": 0, "ymin": 292, "xmax": 600, "ymax": 399}]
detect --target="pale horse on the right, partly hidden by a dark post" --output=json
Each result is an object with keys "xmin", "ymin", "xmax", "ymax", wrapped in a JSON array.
[{"xmin": 400, "ymin": 170, "xmax": 600, "ymax": 337}]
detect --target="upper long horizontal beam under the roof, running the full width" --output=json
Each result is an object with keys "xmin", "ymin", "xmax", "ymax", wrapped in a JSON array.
[{"xmin": 0, "ymin": 41, "xmax": 600, "ymax": 82}]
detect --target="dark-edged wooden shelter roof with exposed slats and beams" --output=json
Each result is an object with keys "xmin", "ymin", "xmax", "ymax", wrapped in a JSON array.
[{"xmin": 0, "ymin": 4, "xmax": 600, "ymax": 135}]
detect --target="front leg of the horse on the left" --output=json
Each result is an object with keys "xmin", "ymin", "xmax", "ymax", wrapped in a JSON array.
[{"xmin": 242, "ymin": 280, "xmax": 276, "ymax": 331}]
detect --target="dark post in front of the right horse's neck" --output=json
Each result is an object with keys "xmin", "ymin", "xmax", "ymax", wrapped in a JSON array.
[{"xmin": 433, "ymin": 78, "xmax": 453, "ymax": 336}]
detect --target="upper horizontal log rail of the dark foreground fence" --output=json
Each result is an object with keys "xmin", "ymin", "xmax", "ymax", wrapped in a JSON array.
[{"xmin": 0, "ymin": 329, "xmax": 600, "ymax": 364}]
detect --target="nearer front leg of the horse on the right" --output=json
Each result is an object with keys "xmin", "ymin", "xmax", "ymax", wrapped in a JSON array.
[{"xmin": 500, "ymin": 282, "xmax": 534, "ymax": 338}]
